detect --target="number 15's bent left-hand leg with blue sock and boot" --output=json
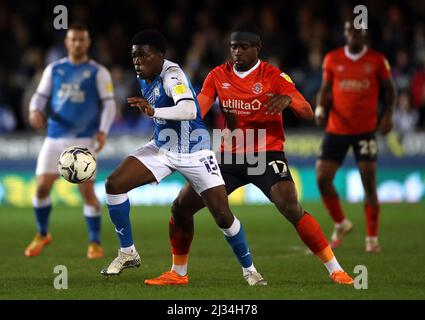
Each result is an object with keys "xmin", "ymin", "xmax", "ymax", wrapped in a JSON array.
[{"xmin": 101, "ymin": 156, "xmax": 156, "ymax": 276}]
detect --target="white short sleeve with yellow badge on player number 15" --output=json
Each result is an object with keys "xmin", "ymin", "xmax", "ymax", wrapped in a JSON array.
[{"xmin": 164, "ymin": 67, "xmax": 195, "ymax": 105}]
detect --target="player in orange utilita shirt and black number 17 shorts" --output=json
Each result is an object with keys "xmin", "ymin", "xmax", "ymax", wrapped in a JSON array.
[{"xmin": 145, "ymin": 25, "xmax": 353, "ymax": 285}]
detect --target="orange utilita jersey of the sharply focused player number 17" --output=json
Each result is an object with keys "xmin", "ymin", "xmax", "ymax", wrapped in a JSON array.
[{"xmin": 200, "ymin": 61, "xmax": 308, "ymax": 153}]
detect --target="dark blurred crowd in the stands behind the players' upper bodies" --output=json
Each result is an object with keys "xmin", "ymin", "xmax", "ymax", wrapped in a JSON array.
[{"xmin": 0, "ymin": 0, "xmax": 425, "ymax": 134}]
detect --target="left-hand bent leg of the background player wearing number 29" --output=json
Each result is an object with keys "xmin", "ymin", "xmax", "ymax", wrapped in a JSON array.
[{"xmin": 316, "ymin": 159, "xmax": 353, "ymax": 249}]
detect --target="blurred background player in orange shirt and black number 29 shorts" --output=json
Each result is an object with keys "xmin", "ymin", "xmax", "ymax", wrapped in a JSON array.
[{"xmin": 315, "ymin": 20, "xmax": 396, "ymax": 252}]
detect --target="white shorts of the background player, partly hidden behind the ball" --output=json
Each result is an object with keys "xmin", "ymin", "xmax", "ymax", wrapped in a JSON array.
[{"xmin": 35, "ymin": 137, "xmax": 95, "ymax": 176}]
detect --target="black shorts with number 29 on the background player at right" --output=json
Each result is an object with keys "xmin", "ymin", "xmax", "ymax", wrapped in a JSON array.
[{"xmin": 318, "ymin": 132, "xmax": 378, "ymax": 164}]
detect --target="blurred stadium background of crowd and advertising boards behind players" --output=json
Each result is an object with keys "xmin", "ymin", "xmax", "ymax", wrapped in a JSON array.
[{"xmin": 0, "ymin": 0, "xmax": 425, "ymax": 207}]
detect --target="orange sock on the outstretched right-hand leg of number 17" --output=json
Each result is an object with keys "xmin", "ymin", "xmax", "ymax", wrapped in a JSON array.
[{"xmin": 296, "ymin": 211, "xmax": 332, "ymax": 255}]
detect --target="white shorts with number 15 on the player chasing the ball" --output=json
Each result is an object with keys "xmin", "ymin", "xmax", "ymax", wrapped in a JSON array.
[{"xmin": 130, "ymin": 141, "xmax": 224, "ymax": 195}]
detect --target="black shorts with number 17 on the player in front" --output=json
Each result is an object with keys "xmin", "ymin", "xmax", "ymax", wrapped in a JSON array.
[{"xmin": 217, "ymin": 151, "xmax": 293, "ymax": 200}]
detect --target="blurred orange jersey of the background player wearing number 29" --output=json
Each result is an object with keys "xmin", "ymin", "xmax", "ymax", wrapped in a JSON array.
[{"xmin": 323, "ymin": 47, "xmax": 391, "ymax": 134}]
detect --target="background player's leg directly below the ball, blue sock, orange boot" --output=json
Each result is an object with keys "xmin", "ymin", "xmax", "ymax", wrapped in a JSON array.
[{"xmin": 78, "ymin": 180, "xmax": 104, "ymax": 259}]
